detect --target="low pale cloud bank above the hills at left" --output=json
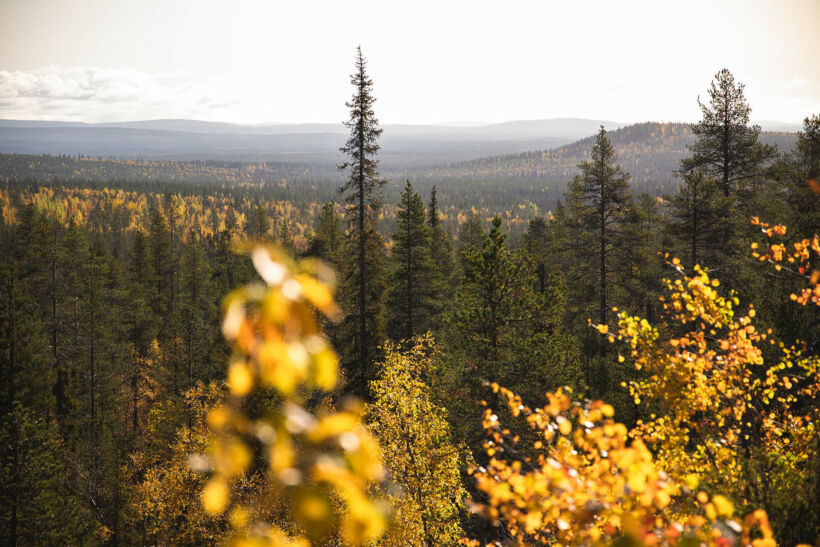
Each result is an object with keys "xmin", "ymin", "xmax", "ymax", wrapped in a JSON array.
[{"xmin": 0, "ymin": 66, "xmax": 239, "ymax": 122}]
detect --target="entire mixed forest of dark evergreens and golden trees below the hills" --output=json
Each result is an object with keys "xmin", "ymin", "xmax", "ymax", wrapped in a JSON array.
[{"xmin": 0, "ymin": 51, "xmax": 820, "ymax": 547}]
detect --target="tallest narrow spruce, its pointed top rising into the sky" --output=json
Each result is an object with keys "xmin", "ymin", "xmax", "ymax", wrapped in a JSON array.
[{"xmin": 339, "ymin": 47, "xmax": 386, "ymax": 396}]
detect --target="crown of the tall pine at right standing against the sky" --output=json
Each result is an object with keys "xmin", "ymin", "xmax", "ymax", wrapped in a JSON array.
[{"xmin": 681, "ymin": 68, "xmax": 777, "ymax": 197}]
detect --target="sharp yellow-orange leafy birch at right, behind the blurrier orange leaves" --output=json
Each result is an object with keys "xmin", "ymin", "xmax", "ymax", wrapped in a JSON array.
[{"xmin": 599, "ymin": 255, "xmax": 820, "ymax": 544}]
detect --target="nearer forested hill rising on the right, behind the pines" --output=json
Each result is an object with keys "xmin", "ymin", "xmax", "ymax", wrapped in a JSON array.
[{"xmin": 425, "ymin": 122, "xmax": 797, "ymax": 193}]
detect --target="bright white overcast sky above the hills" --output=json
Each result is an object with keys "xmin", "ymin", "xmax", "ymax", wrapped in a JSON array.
[{"xmin": 0, "ymin": 0, "xmax": 820, "ymax": 124}]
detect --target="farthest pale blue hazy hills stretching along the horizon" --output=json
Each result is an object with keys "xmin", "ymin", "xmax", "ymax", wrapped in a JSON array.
[{"xmin": 0, "ymin": 118, "xmax": 622, "ymax": 172}]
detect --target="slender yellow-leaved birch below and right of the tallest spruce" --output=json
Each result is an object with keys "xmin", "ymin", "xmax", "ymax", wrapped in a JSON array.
[{"xmin": 367, "ymin": 333, "xmax": 467, "ymax": 545}]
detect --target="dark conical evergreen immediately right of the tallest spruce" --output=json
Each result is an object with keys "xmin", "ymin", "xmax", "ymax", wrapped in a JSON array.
[{"xmin": 387, "ymin": 180, "xmax": 436, "ymax": 341}]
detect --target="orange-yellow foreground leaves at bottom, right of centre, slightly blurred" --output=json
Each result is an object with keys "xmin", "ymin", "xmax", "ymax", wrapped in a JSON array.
[{"xmin": 463, "ymin": 384, "xmax": 771, "ymax": 546}]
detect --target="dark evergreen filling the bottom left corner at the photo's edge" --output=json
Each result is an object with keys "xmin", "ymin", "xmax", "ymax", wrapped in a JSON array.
[{"xmin": 0, "ymin": 263, "xmax": 86, "ymax": 545}]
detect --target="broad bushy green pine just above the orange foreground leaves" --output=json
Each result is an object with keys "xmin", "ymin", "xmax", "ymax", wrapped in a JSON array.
[{"xmin": 444, "ymin": 217, "xmax": 580, "ymax": 445}]
